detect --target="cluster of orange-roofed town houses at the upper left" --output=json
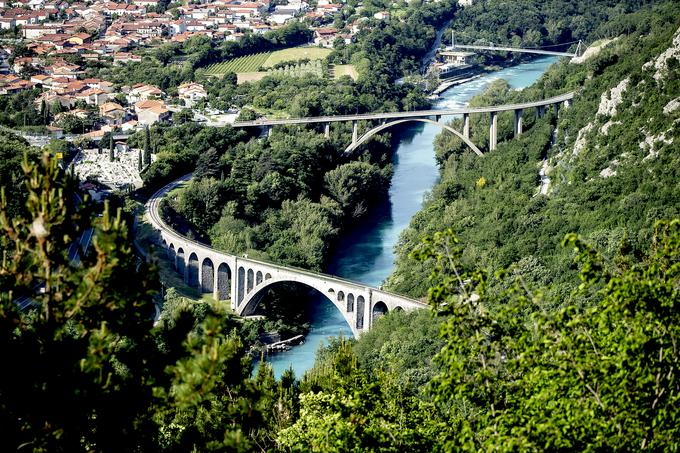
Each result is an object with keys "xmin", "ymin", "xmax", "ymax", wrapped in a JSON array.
[{"xmin": 0, "ymin": 0, "xmax": 406, "ymax": 134}]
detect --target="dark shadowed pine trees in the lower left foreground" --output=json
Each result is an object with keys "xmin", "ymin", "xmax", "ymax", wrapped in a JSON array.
[{"xmin": 0, "ymin": 155, "xmax": 290, "ymax": 452}]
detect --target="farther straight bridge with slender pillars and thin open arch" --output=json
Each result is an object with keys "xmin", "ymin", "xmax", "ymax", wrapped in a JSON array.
[{"xmin": 232, "ymin": 92, "xmax": 574, "ymax": 156}]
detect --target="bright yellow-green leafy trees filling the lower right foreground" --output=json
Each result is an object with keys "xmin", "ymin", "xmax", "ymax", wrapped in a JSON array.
[{"xmin": 278, "ymin": 224, "xmax": 680, "ymax": 452}]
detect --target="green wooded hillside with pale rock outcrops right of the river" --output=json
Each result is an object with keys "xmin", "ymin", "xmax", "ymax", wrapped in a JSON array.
[{"xmin": 388, "ymin": 4, "xmax": 680, "ymax": 304}]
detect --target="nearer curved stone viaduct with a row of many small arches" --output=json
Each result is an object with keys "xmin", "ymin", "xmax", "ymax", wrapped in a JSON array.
[{"xmin": 146, "ymin": 174, "xmax": 427, "ymax": 337}]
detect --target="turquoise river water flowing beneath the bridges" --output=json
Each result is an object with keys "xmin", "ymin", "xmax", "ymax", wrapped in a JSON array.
[{"xmin": 267, "ymin": 57, "xmax": 557, "ymax": 378}]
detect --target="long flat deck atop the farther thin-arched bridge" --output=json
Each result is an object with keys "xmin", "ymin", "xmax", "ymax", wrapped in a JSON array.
[{"xmin": 232, "ymin": 92, "xmax": 574, "ymax": 127}]
